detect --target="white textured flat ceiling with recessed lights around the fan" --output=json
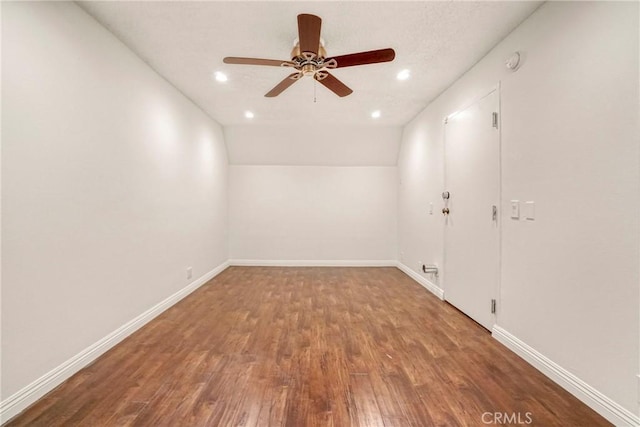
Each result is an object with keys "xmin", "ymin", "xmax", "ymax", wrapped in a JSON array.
[{"xmin": 80, "ymin": 1, "xmax": 541, "ymax": 127}]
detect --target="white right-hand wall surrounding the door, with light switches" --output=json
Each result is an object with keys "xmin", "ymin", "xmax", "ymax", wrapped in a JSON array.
[{"xmin": 399, "ymin": 2, "xmax": 640, "ymax": 422}]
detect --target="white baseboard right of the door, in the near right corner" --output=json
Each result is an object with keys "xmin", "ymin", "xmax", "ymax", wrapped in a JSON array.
[{"xmin": 491, "ymin": 326, "xmax": 640, "ymax": 426}]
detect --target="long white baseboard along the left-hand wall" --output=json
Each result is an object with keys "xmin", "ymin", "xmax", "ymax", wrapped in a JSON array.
[{"xmin": 0, "ymin": 261, "xmax": 229, "ymax": 424}]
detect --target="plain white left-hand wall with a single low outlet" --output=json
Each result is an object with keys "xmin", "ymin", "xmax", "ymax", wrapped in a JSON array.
[{"xmin": 2, "ymin": 2, "xmax": 228, "ymax": 399}]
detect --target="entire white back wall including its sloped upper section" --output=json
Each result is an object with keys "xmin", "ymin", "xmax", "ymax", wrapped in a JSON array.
[{"xmin": 225, "ymin": 124, "xmax": 402, "ymax": 265}]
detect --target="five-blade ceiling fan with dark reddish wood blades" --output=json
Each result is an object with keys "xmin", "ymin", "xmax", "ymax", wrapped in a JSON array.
[{"xmin": 224, "ymin": 13, "xmax": 396, "ymax": 98}]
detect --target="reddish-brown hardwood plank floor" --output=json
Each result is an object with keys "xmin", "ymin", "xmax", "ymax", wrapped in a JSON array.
[{"xmin": 8, "ymin": 267, "xmax": 609, "ymax": 427}]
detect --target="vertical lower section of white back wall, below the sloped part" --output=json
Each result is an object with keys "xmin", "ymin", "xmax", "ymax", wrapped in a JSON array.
[{"xmin": 229, "ymin": 165, "xmax": 397, "ymax": 264}]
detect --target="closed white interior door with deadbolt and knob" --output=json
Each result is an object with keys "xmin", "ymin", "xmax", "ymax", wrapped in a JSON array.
[{"xmin": 443, "ymin": 90, "xmax": 500, "ymax": 330}]
